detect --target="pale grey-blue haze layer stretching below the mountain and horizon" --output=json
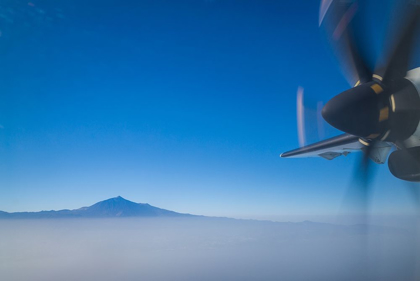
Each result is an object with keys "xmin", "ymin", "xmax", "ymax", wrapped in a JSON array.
[{"xmin": 0, "ymin": 217, "xmax": 416, "ymax": 280}]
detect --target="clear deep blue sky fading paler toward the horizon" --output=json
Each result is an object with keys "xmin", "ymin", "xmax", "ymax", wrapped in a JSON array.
[{"xmin": 0, "ymin": 0, "xmax": 411, "ymax": 218}]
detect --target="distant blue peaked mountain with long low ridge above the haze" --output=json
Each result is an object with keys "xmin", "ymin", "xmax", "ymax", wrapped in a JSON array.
[{"xmin": 0, "ymin": 196, "xmax": 193, "ymax": 219}]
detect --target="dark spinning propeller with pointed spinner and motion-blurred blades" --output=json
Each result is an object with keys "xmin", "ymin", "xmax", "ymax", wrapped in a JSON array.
[{"xmin": 319, "ymin": 0, "xmax": 420, "ymax": 221}]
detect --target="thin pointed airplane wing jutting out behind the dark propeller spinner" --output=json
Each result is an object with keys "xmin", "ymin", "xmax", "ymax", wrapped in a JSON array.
[{"xmin": 280, "ymin": 134, "xmax": 391, "ymax": 164}]
